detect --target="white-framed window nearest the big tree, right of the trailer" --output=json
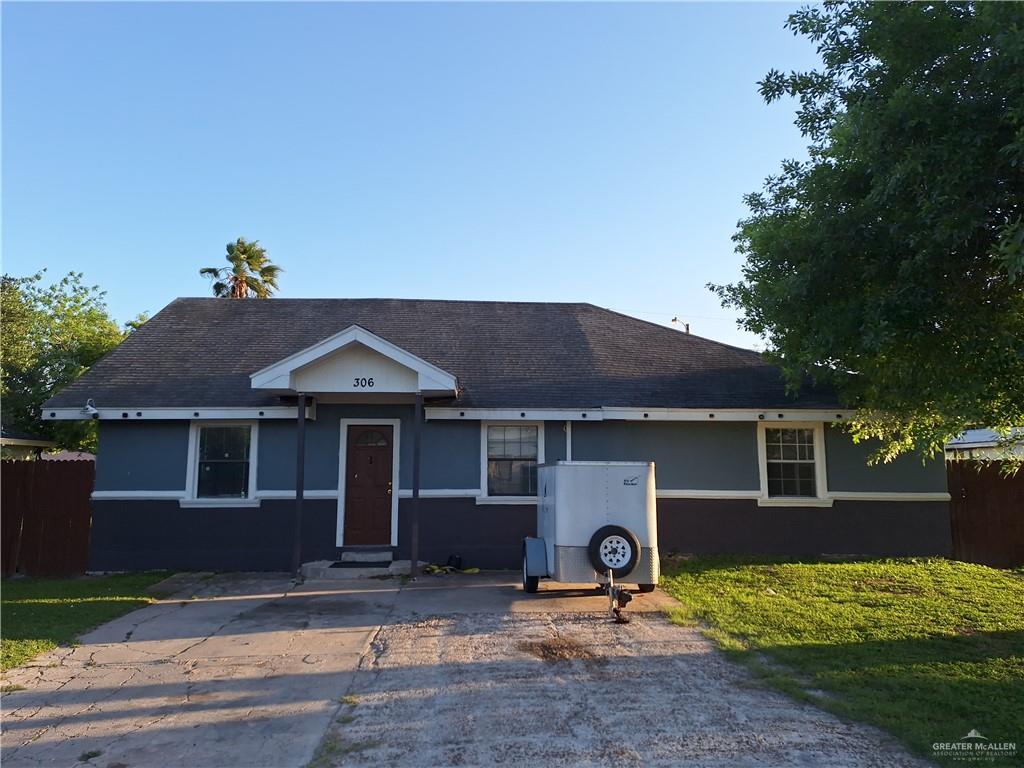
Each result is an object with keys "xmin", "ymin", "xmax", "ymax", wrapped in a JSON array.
[{"xmin": 758, "ymin": 422, "xmax": 831, "ymax": 506}]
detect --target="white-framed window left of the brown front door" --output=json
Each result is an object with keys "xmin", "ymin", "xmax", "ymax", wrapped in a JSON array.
[{"xmin": 185, "ymin": 421, "xmax": 259, "ymax": 505}]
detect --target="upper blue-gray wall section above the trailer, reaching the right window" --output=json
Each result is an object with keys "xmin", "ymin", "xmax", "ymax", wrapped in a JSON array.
[{"xmin": 572, "ymin": 421, "xmax": 761, "ymax": 490}]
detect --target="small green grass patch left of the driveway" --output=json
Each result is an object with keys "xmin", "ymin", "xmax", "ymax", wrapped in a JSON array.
[{"xmin": 0, "ymin": 572, "xmax": 168, "ymax": 670}]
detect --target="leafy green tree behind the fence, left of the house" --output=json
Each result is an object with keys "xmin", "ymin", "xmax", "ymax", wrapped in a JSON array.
[{"xmin": 0, "ymin": 272, "xmax": 145, "ymax": 451}]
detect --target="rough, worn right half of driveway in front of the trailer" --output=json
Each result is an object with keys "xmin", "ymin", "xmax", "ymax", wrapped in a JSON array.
[{"xmin": 316, "ymin": 580, "xmax": 928, "ymax": 768}]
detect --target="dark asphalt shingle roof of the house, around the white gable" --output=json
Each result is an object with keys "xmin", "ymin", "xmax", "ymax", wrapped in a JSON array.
[{"xmin": 46, "ymin": 298, "xmax": 836, "ymax": 409}]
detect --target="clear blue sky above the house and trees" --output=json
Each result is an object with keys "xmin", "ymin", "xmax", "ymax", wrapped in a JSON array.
[{"xmin": 2, "ymin": 3, "xmax": 816, "ymax": 346}]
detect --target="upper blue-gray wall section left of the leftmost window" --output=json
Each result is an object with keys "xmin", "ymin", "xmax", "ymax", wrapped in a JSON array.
[{"xmin": 95, "ymin": 421, "xmax": 188, "ymax": 490}]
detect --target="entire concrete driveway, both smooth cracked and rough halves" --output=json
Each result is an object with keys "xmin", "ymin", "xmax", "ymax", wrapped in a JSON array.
[{"xmin": 0, "ymin": 575, "xmax": 924, "ymax": 768}]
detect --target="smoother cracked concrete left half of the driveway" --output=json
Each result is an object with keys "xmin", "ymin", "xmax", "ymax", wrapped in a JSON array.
[{"xmin": 0, "ymin": 574, "xmax": 398, "ymax": 768}]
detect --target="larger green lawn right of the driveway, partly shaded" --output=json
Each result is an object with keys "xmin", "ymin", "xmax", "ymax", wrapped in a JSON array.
[{"xmin": 662, "ymin": 558, "xmax": 1024, "ymax": 765}]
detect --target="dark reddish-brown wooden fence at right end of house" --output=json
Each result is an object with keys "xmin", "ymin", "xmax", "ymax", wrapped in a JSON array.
[{"xmin": 946, "ymin": 461, "xmax": 1024, "ymax": 568}]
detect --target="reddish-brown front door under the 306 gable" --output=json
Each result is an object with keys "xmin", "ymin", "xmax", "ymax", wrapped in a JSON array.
[{"xmin": 344, "ymin": 425, "xmax": 394, "ymax": 546}]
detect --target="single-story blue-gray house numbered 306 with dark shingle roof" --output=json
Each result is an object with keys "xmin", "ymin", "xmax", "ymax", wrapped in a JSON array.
[{"xmin": 43, "ymin": 299, "xmax": 950, "ymax": 569}]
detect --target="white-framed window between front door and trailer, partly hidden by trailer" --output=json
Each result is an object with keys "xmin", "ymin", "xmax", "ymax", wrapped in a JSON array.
[{"xmin": 480, "ymin": 422, "xmax": 544, "ymax": 503}]
